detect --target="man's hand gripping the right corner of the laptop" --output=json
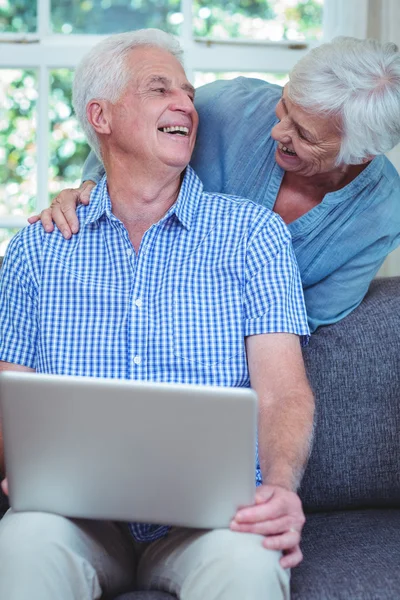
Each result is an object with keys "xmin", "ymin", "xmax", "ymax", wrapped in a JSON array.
[{"xmin": 231, "ymin": 485, "xmax": 306, "ymax": 569}]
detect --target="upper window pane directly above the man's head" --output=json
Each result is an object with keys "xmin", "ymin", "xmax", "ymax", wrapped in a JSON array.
[{"xmin": 51, "ymin": 0, "xmax": 183, "ymax": 34}]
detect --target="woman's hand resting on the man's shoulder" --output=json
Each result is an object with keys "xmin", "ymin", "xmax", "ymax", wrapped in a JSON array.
[{"xmin": 28, "ymin": 180, "xmax": 96, "ymax": 240}]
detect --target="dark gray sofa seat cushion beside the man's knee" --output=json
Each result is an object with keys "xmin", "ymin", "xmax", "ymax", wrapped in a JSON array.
[{"xmin": 291, "ymin": 509, "xmax": 400, "ymax": 600}]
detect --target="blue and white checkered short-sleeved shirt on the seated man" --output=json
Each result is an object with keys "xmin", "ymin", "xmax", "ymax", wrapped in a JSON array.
[{"xmin": 0, "ymin": 167, "xmax": 308, "ymax": 541}]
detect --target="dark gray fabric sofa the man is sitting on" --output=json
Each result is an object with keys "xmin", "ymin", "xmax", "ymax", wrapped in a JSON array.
[{"xmin": 3, "ymin": 278, "xmax": 400, "ymax": 600}]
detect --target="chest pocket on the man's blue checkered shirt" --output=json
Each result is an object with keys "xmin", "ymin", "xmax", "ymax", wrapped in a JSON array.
[{"xmin": 173, "ymin": 276, "xmax": 245, "ymax": 366}]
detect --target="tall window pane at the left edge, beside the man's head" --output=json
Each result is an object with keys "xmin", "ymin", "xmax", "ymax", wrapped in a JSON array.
[{"xmin": 0, "ymin": 69, "xmax": 37, "ymax": 217}]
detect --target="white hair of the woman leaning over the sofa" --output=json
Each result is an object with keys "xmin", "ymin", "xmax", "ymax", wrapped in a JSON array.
[{"xmin": 288, "ymin": 37, "xmax": 400, "ymax": 165}]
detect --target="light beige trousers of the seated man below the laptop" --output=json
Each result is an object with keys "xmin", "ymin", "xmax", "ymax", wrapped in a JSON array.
[{"xmin": 0, "ymin": 510, "xmax": 290, "ymax": 600}]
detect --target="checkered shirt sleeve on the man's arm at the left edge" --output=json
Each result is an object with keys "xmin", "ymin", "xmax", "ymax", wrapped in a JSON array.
[{"xmin": 0, "ymin": 232, "xmax": 38, "ymax": 369}]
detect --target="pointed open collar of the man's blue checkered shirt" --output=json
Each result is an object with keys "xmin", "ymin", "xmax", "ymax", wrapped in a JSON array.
[{"xmin": 83, "ymin": 166, "xmax": 203, "ymax": 229}]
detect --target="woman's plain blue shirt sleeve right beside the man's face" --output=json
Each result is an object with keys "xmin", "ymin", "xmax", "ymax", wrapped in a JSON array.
[{"xmin": 191, "ymin": 77, "xmax": 282, "ymax": 195}]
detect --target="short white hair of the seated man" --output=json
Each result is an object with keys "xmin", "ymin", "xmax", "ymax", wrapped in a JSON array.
[{"xmin": 72, "ymin": 29, "xmax": 183, "ymax": 158}]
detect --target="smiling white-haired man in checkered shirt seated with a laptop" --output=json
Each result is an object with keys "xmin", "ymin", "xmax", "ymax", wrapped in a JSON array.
[{"xmin": 0, "ymin": 30, "xmax": 313, "ymax": 600}]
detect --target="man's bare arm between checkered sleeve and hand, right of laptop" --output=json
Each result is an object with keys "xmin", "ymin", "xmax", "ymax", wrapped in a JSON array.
[{"xmin": 246, "ymin": 333, "xmax": 314, "ymax": 491}]
